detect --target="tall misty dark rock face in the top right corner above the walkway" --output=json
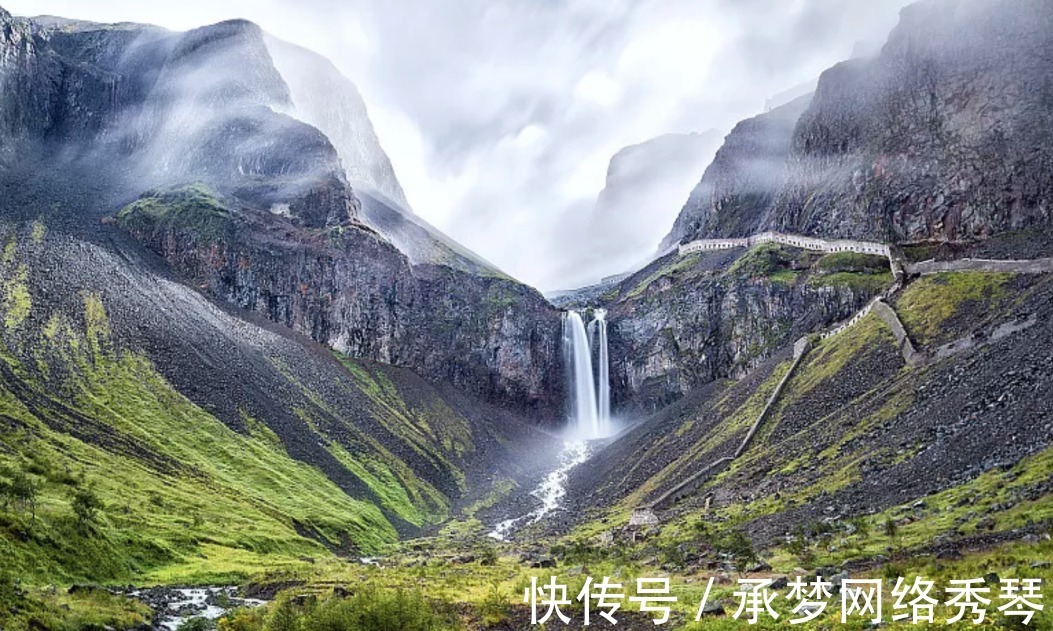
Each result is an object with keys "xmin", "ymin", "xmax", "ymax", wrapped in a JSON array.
[{"xmin": 770, "ymin": 0, "xmax": 1053, "ymax": 241}]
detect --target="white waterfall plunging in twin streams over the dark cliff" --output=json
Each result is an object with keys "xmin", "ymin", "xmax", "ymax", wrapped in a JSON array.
[{"xmin": 563, "ymin": 310, "xmax": 611, "ymax": 438}]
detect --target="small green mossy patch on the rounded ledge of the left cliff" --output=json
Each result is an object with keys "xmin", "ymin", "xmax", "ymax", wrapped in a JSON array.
[{"xmin": 117, "ymin": 184, "xmax": 234, "ymax": 240}]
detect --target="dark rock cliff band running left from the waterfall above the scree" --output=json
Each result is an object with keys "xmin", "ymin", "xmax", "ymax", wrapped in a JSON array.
[{"xmin": 119, "ymin": 189, "xmax": 562, "ymax": 421}]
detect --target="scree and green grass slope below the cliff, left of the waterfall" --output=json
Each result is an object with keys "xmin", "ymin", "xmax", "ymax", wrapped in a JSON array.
[{"xmin": 0, "ymin": 224, "xmax": 522, "ymax": 585}]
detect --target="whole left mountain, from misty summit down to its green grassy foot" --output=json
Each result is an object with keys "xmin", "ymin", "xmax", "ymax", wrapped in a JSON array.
[{"xmin": 0, "ymin": 3, "xmax": 562, "ymax": 580}]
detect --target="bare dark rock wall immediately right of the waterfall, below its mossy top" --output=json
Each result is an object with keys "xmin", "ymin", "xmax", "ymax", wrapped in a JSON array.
[{"xmin": 608, "ymin": 258, "xmax": 871, "ymax": 412}]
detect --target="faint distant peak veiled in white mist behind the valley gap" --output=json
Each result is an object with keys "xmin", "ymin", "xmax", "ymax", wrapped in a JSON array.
[{"xmin": 589, "ymin": 131, "xmax": 720, "ymax": 264}]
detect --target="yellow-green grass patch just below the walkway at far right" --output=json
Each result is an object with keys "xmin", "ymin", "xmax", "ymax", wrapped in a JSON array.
[{"xmin": 896, "ymin": 272, "xmax": 1013, "ymax": 344}]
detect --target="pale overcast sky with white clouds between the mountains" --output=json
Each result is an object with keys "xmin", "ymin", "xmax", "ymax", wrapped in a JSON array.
[{"xmin": 6, "ymin": 0, "xmax": 909, "ymax": 290}]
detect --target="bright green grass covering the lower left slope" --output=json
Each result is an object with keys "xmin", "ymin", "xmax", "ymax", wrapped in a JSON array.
[{"xmin": 0, "ymin": 294, "xmax": 416, "ymax": 589}]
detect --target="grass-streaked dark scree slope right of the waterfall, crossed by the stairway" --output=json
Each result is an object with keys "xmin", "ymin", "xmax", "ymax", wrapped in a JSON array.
[{"xmin": 570, "ymin": 267, "xmax": 1053, "ymax": 585}]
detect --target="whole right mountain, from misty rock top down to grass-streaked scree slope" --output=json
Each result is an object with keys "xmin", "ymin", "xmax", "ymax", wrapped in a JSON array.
[{"xmin": 560, "ymin": 0, "xmax": 1053, "ymax": 556}]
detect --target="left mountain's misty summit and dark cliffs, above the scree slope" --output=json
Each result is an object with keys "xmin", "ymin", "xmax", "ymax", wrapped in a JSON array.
[{"xmin": 0, "ymin": 8, "xmax": 562, "ymax": 421}]
